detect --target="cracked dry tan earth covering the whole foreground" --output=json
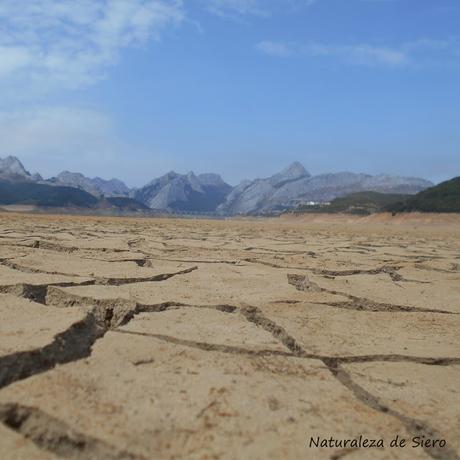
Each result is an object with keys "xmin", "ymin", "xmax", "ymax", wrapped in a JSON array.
[{"xmin": 0, "ymin": 214, "xmax": 460, "ymax": 460}]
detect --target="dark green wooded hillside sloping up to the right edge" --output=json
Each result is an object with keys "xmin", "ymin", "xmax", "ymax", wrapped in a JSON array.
[{"xmin": 386, "ymin": 176, "xmax": 460, "ymax": 212}]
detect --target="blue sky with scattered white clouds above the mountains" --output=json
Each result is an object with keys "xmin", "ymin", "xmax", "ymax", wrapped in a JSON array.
[{"xmin": 0, "ymin": 0, "xmax": 460, "ymax": 186}]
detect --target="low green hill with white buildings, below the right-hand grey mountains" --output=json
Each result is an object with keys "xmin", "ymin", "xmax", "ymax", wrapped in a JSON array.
[{"xmin": 294, "ymin": 192, "xmax": 409, "ymax": 215}]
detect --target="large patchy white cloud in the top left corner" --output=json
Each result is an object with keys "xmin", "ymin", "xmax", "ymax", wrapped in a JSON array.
[{"xmin": 0, "ymin": 0, "xmax": 184, "ymax": 88}]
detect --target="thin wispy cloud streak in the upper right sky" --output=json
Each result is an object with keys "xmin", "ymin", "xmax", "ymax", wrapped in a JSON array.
[{"xmin": 256, "ymin": 39, "xmax": 460, "ymax": 67}]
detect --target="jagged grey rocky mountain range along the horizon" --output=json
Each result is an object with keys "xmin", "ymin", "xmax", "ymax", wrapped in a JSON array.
[{"xmin": 0, "ymin": 156, "xmax": 433, "ymax": 216}]
